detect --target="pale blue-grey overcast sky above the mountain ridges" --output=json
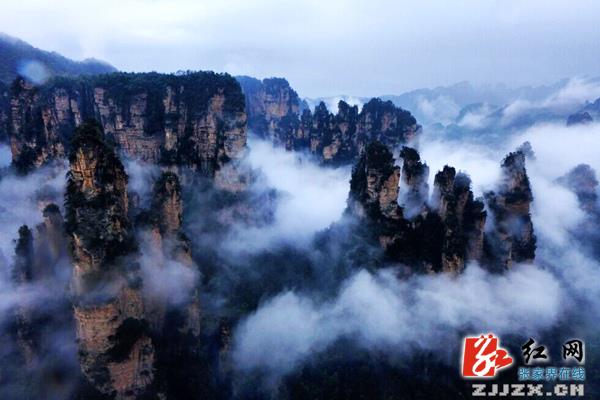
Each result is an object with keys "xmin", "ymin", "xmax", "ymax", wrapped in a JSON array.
[{"xmin": 0, "ymin": 0, "xmax": 600, "ymax": 96}]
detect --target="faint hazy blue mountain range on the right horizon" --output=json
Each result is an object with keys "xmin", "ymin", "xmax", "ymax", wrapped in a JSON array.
[{"xmin": 305, "ymin": 78, "xmax": 600, "ymax": 140}]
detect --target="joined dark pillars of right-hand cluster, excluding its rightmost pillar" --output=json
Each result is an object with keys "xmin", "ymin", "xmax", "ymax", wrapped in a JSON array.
[{"xmin": 348, "ymin": 142, "xmax": 485, "ymax": 273}]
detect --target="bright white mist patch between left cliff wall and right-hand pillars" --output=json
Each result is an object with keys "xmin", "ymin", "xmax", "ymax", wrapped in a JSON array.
[{"xmin": 220, "ymin": 137, "xmax": 351, "ymax": 252}]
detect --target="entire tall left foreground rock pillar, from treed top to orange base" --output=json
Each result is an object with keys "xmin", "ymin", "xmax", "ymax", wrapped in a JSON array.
[{"xmin": 65, "ymin": 122, "xmax": 155, "ymax": 398}]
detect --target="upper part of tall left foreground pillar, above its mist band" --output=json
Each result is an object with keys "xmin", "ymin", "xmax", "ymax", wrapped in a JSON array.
[{"xmin": 65, "ymin": 122, "xmax": 135, "ymax": 276}]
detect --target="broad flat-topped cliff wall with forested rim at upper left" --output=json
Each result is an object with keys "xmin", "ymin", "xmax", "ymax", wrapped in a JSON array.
[{"xmin": 10, "ymin": 72, "xmax": 246, "ymax": 184}]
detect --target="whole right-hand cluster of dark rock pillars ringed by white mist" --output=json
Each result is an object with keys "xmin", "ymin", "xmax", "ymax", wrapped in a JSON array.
[{"xmin": 347, "ymin": 142, "xmax": 535, "ymax": 273}]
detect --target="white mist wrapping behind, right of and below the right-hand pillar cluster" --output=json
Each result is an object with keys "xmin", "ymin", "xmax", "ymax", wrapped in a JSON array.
[{"xmin": 227, "ymin": 120, "xmax": 600, "ymax": 385}]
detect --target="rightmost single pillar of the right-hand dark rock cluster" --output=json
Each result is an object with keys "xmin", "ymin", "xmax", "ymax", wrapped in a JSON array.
[{"xmin": 485, "ymin": 150, "xmax": 536, "ymax": 271}]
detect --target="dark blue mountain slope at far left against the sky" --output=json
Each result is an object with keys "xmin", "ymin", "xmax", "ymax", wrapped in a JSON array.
[{"xmin": 0, "ymin": 33, "xmax": 117, "ymax": 83}]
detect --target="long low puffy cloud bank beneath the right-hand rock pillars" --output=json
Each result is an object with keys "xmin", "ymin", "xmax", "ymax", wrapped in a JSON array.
[{"xmin": 233, "ymin": 265, "xmax": 564, "ymax": 376}]
